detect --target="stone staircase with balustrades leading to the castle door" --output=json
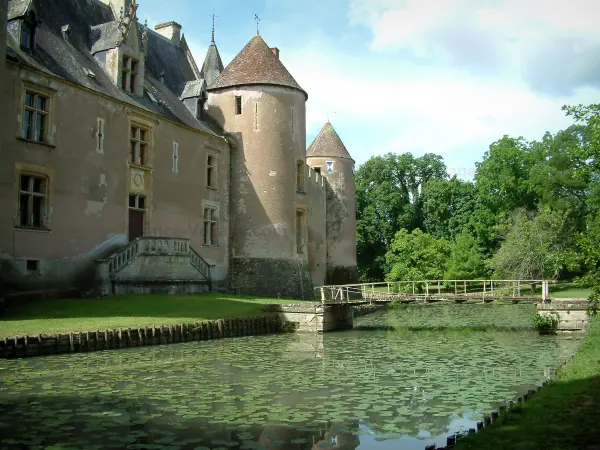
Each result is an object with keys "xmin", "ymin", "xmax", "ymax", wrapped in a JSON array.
[{"xmin": 97, "ymin": 236, "xmax": 212, "ymax": 296}]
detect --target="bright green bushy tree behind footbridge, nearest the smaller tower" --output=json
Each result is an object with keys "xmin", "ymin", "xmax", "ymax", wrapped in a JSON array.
[{"xmin": 386, "ymin": 228, "xmax": 450, "ymax": 281}]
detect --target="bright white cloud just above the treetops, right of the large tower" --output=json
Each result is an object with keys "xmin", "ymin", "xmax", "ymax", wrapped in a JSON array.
[{"xmin": 282, "ymin": 33, "xmax": 600, "ymax": 173}]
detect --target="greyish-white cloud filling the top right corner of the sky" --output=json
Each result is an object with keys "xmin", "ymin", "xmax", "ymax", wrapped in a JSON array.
[{"xmin": 349, "ymin": 0, "xmax": 600, "ymax": 94}]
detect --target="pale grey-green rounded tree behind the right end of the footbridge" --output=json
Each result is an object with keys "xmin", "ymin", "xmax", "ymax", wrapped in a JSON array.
[{"xmin": 491, "ymin": 208, "xmax": 578, "ymax": 280}]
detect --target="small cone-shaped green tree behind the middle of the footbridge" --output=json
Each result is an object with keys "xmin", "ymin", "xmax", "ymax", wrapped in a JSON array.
[{"xmin": 444, "ymin": 233, "xmax": 489, "ymax": 280}]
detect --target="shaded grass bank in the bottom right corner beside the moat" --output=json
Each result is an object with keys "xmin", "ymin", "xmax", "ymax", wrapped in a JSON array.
[{"xmin": 455, "ymin": 318, "xmax": 600, "ymax": 450}]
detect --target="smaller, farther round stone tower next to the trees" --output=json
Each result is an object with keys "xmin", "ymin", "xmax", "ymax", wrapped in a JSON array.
[{"xmin": 306, "ymin": 122, "xmax": 358, "ymax": 284}]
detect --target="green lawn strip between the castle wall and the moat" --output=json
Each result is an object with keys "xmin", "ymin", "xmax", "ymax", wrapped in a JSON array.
[{"xmin": 0, "ymin": 293, "xmax": 308, "ymax": 338}]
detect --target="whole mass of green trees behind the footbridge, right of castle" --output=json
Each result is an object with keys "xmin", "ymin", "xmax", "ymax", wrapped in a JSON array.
[{"xmin": 356, "ymin": 104, "xmax": 600, "ymax": 303}]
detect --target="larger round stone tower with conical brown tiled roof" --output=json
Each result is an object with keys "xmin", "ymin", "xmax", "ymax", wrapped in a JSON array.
[{"xmin": 208, "ymin": 35, "xmax": 313, "ymax": 298}]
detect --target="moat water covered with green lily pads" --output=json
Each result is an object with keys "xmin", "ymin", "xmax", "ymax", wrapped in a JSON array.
[{"xmin": 0, "ymin": 305, "xmax": 579, "ymax": 450}]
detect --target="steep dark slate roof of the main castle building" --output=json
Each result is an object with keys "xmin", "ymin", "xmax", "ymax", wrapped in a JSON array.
[{"xmin": 7, "ymin": 0, "xmax": 218, "ymax": 136}]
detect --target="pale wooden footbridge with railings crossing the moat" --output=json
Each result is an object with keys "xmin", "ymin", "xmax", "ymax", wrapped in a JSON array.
[{"xmin": 316, "ymin": 280, "xmax": 550, "ymax": 305}]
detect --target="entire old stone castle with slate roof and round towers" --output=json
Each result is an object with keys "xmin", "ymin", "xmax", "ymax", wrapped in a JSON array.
[{"xmin": 0, "ymin": 0, "xmax": 356, "ymax": 299}]
